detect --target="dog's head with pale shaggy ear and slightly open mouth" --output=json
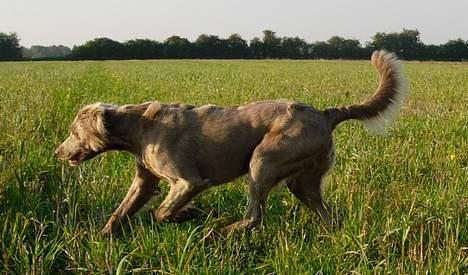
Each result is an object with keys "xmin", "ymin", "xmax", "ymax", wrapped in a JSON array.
[{"xmin": 55, "ymin": 103, "xmax": 113, "ymax": 166}]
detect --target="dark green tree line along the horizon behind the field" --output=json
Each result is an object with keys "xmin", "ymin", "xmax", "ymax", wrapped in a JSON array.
[{"xmin": 0, "ymin": 29, "xmax": 468, "ymax": 61}]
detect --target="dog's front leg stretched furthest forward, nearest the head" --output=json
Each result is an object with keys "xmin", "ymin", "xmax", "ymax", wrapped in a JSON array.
[{"xmin": 101, "ymin": 163, "xmax": 159, "ymax": 234}]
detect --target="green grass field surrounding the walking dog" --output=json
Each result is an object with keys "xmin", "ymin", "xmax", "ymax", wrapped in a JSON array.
[{"xmin": 0, "ymin": 58, "xmax": 468, "ymax": 274}]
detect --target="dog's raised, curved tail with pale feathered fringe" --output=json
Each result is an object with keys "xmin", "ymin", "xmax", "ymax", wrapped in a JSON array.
[{"xmin": 324, "ymin": 51, "xmax": 408, "ymax": 133}]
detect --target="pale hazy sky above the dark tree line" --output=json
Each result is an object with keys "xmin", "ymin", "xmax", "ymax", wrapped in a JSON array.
[{"xmin": 0, "ymin": 0, "xmax": 468, "ymax": 47}]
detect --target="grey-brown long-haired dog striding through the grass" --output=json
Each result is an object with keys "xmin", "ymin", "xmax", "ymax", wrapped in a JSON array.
[{"xmin": 55, "ymin": 51, "xmax": 408, "ymax": 234}]
